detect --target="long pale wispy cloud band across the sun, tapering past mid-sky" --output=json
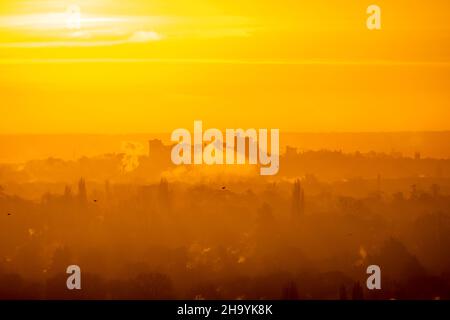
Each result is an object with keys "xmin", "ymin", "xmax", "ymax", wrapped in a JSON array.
[{"xmin": 0, "ymin": 13, "xmax": 254, "ymax": 49}]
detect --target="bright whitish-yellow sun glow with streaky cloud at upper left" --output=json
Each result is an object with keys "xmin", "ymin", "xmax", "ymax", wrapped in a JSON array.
[{"xmin": 0, "ymin": 4, "xmax": 167, "ymax": 48}]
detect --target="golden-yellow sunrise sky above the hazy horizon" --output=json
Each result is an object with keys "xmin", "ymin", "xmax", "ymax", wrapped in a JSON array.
[{"xmin": 0, "ymin": 0, "xmax": 450, "ymax": 133}]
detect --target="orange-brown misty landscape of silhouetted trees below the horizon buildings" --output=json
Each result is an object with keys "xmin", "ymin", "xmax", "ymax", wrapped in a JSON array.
[{"xmin": 0, "ymin": 145, "xmax": 450, "ymax": 299}]
